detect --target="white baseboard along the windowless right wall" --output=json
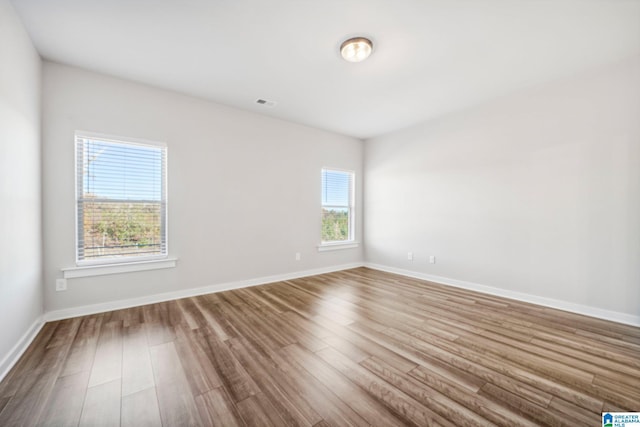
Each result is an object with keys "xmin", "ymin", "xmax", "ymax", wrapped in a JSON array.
[{"xmin": 364, "ymin": 263, "xmax": 640, "ymax": 326}]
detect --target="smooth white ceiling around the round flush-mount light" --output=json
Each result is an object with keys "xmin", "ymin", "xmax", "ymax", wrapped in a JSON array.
[{"xmin": 12, "ymin": 0, "xmax": 640, "ymax": 138}]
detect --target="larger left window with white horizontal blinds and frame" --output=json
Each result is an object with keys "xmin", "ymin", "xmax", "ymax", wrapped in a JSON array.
[{"xmin": 76, "ymin": 133, "xmax": 167, "ymax": 265}]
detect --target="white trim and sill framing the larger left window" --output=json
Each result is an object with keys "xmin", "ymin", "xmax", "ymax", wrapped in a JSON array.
[{"xmin": 74, "ymin": 130, "xmax": 170, "ymax": 268}]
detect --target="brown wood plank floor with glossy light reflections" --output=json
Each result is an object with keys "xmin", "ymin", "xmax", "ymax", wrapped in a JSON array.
[{"xmin": 0, "ymin": 268, "xmax": 640, "ymax": 427}]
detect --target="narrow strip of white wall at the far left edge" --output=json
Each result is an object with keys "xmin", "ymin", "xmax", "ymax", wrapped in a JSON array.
[{"xmin": 0, "ymin": 0, "xmax": 42, "ymax": 372}]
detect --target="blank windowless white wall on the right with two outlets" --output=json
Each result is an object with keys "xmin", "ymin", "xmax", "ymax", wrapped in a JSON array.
[{"xmin": 365, "ymin": 57, "xmax": 640, "ymax": 322}]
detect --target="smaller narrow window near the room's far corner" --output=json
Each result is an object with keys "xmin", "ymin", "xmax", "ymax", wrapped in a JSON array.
[{"xmin": 322, "ymin": 169, "xmax": 354, "ymax": 244}]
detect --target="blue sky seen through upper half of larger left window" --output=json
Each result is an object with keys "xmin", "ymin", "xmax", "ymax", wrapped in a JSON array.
[{"xmin": 83, "ymin": 139, "xmax": 163, "ymax": 201}]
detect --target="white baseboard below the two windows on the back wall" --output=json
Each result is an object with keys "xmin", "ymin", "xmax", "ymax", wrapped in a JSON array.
[{"xmin": 44, "ymin": 262, "xmax": 364, "ymax": 322}]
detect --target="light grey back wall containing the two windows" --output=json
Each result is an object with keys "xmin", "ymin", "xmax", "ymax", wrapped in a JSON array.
[{"xmin": 43, "ymin": 62, "xmax": 363, "ymax": 311}]
